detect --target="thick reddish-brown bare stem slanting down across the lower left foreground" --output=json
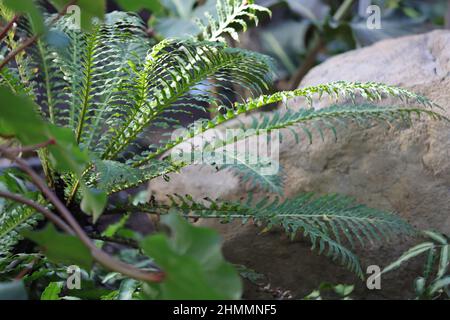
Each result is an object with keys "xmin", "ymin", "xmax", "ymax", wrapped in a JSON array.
[{"xmin": 0, "ymin": 146, "xmax": 164, "ymax": 282}]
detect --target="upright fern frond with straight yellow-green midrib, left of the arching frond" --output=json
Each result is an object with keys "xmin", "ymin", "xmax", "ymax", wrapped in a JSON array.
[{"xmin": 45, "ymin": 12, "xmax": 149, "ymax": 149}]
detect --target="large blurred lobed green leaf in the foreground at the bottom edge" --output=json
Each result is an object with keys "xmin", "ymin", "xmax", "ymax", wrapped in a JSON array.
[{"xmin": 141, "ymin": 213, "xmax": 242, "ymax": 299}]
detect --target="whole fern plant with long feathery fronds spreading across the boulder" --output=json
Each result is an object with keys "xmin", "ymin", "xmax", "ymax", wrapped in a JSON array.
[{"xmin": 0, "ymin": 0, "xmax": 445, "ymax": 296}]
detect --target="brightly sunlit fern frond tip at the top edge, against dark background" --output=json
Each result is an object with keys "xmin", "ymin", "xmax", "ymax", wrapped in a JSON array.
[{"xmin": 198, "ymin": 0, "xmax": 272, "ymax": 42}]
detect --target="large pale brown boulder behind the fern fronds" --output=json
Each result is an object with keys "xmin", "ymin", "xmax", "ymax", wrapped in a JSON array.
[{"xmin": 150, "ymin": 31, "xmax": 450, "ymax": 298}]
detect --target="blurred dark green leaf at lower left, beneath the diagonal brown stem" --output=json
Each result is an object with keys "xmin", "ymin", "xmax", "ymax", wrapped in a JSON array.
[{"xmin": 23, "ymin": 224, "xmax": 93, "ymax": 270}]
